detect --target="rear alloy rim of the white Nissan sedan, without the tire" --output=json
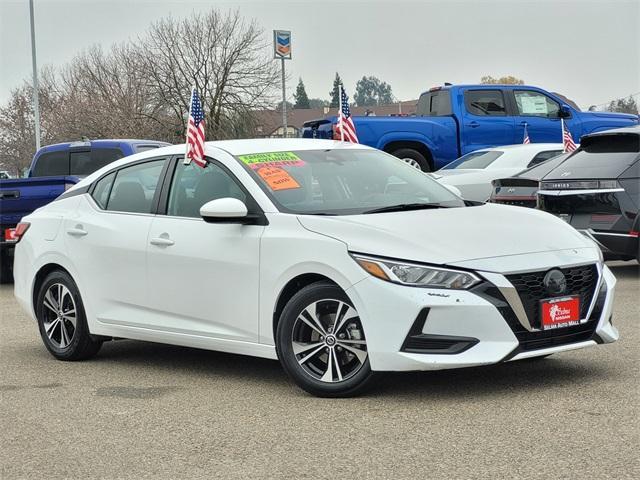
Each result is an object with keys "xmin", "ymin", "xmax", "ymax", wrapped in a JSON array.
[{"xmin": 42, "ymin": 283, "xmax": 77, "ymax": 349}]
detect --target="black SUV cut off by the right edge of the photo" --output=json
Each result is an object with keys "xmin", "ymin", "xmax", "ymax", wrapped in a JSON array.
[{"xmin": 538, "ymin": 126, "xmax": 640, "ymax": 261}]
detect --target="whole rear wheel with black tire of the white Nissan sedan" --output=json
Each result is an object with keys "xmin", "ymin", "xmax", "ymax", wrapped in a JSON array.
[{"xmin": 35, "ymin": 270, "xmax": 102, "ymax": 360}]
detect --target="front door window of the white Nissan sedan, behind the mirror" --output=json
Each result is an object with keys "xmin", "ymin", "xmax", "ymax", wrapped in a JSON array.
[{"xmin": 167, "ymin": 159, "xmax": 247, "ymax": 218}]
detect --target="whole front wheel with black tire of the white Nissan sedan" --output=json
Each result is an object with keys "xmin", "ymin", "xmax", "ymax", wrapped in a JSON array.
[{"xmin": 276, "ymin": 282, "xmax": 374, "ymax": 397}]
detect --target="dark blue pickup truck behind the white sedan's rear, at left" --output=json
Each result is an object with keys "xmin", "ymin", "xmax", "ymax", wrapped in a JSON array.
[{"xmin": 0, "ymin": 140, "xmax": 169, "ymax": 282}]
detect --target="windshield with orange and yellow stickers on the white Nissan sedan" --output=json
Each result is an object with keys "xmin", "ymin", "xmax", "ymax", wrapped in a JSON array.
[{"xmin": 236, "ymin": 148, "xmax": 464, "ymax": 215}]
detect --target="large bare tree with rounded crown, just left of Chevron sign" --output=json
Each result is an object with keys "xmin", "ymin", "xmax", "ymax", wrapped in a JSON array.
[{"xmin": 140, "ymin": 10, "xmax": 278, "ymax": 139}]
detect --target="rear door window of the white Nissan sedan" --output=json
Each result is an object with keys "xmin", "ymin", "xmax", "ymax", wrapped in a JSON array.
[{"xmin": 107, "ymin": 159, "xmax": 165, "ymax": 213}]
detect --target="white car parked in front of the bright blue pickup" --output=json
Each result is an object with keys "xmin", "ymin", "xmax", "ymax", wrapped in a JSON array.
[{"xmin": 430, "ymin": 143, "xmax": 562, "ymax": 202}]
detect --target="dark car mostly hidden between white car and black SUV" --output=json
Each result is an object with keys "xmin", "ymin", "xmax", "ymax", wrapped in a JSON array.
[{"xmin": 489, "ymin": 153, "xmax": 569, "ymax": 208}]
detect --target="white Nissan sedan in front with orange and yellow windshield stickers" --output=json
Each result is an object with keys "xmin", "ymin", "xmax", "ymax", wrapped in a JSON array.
[{"xmin": 14, "ymin": 139, "xmax": 618, "ymax": 396}]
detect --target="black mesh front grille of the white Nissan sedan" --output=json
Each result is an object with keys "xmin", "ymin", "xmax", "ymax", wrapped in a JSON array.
[{"xmin": 507, "ymin": 264, "xmax": 598, "ymax": 329}]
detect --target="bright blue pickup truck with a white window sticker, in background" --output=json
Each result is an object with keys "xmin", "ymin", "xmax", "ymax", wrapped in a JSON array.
[{"xmin": 302, "ymin": 85, "xmax": 638, "ymax": 171}]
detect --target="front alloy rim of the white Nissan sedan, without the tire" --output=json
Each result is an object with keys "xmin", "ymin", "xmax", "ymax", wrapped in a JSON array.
[{"xmin": 291, "ymin": 299, "xmax": 367, "ymax": 383}]
